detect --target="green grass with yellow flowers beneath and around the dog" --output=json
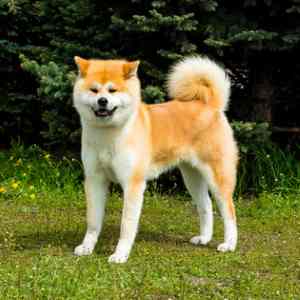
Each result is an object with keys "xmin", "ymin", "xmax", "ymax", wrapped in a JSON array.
[{"xmin": 0, "ymin": 147, "xmax": 300, "ymax": 299}]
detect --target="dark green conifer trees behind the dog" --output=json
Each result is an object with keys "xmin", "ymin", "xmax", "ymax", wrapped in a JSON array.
[{"xmin": 0, "ymin": 0, "xmax": 300, "ymax": 193}]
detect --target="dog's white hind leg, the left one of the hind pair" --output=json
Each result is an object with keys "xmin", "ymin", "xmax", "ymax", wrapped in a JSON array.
[{"xmin": 180, "ymin": 164, "xmax": 213, "ymax": 245}]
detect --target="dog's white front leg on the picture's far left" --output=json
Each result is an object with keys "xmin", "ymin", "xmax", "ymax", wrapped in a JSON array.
[{"xmin": 74, "ymin": 174, "xmax": 108, "ymax": 256}]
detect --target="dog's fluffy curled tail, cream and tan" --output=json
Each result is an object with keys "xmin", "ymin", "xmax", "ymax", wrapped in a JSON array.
[{"xmin": 167, "ymin": 56, "xmax": 230, "ymax": 111}]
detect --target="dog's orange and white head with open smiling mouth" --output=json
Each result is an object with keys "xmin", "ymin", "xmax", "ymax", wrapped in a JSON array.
[{"xmin": 73, "ymin": 56, "xmax": 140, "ymax": 127}]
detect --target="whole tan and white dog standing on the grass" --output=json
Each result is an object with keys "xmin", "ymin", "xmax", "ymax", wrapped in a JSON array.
[{"xmin": 74, "ymin": 56, "xmax": 238, "ymax": 263}]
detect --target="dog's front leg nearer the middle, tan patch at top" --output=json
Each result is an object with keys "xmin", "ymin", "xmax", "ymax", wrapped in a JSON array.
[{"xmin": 108, "ymin": 180, "xmax": 146, "ymax": 263}]
